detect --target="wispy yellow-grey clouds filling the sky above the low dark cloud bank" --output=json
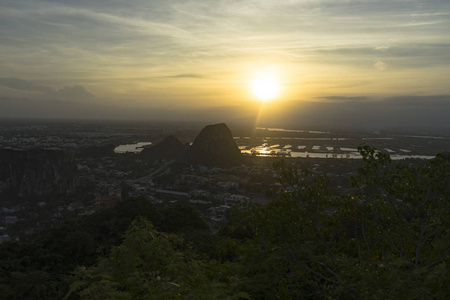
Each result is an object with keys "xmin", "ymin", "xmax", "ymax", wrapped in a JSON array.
[{"xmin": 0, "ymin": 0, "xmax": 450, "ymax": 123}]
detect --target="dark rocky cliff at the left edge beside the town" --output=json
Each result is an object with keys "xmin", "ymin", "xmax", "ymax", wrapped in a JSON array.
[{"xmin": 0, "ymin": 149, "xmax": 77, "ymax": 197}]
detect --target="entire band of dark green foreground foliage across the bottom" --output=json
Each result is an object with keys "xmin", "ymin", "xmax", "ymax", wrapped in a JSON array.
[{"xmin": 0, "ymin": 146, "xmax": 450, "ymax": 299}]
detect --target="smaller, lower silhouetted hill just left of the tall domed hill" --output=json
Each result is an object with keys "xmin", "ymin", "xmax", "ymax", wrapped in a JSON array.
[{"xmin": 140, "ymin": 135, "xmax": 184, "ymax": 160}]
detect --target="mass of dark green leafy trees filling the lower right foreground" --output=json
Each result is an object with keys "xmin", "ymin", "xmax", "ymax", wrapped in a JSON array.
[{"xmin": 228, "ymin": 146, "xmax": 450, "ymax": 299}]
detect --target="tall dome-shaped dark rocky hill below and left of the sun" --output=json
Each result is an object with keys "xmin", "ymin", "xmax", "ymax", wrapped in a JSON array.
[{"xmin": 186, "ymin": 124, "xmax": 242, "ymax": 167}]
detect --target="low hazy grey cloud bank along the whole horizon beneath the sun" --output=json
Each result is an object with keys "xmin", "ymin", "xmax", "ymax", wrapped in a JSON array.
[{"xmin": 0, "ymin": 88, "xmax": 450, "ymax": 129}]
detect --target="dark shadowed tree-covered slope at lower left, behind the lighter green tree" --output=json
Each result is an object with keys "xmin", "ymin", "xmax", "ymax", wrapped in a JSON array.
[{"xmin": 0, "ymin": 198, "xmax": 211, "ymax": 300}]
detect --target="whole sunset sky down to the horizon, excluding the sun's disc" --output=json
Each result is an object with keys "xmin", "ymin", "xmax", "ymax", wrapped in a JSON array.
[{"xmin": 0, "ymin": 0, "xmax": 450, "ymax": 126}]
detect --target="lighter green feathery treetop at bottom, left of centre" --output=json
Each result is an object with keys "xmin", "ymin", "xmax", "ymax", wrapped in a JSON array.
[{"xmin": 66, "ymin": 218, "xmax": 250, "ymax": 299}]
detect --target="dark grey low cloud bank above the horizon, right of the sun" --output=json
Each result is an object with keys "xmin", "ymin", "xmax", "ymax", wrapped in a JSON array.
[{"xmin": 260, "ymin": 94, "xmax": 450, "ymax": 129}]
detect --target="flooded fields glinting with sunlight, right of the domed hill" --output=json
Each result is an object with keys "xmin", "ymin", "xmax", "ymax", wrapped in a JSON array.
[{"xmin": 235, "ymin": 128, "xmax": 450, "ymax": 160}]
